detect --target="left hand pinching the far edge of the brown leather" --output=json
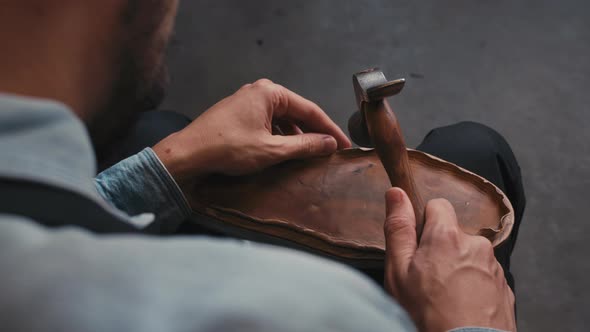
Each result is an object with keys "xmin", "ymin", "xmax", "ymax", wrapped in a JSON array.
[{"xmin": 153, "ymin": 79, "xmax": 351, "ymax": 183}]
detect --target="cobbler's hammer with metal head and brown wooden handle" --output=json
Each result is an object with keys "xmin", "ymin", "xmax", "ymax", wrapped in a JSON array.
[{"xmin": 348, "ymin": 68, "xmax": 424, "ymax": 236}]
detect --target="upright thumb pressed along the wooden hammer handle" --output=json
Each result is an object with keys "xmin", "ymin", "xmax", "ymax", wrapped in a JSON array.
[{"xmin": 384, "ymin": 188, "xmax": 417, "ymax": 280}]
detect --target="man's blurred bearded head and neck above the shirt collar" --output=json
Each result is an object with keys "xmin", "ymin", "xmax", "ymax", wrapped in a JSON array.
[{"xmin": 0, "ymin": 0, "xmax": 178, "ymax": 149}]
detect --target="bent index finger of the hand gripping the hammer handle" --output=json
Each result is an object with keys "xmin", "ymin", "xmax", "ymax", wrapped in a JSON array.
[{"xmin": 420, "ymin": 198, "xmax": 462, "ymax": 246}]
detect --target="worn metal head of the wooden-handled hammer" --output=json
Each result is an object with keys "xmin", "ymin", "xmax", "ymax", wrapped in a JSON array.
[{"xmin": 348, "ymin": 68, "xmax": 406, "ymax": 147}]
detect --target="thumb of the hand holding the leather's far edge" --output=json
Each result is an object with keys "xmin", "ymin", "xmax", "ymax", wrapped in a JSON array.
[{"xmin": 273, "ymin": 133, "xmax": 338, "ymax": 160}]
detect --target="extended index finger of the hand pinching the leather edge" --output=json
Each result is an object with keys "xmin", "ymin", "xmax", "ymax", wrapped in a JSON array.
[{"xmin": 274, "ymin": 85, "xmax": 352, "ymax": 149}]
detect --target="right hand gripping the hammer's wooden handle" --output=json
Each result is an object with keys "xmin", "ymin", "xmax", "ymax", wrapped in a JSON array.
[{"xmin": 385, "ymin": 188, "xmax": 516, "ymax": 331}]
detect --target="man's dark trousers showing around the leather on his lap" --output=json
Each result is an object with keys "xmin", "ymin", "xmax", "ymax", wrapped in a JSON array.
[{"xmin": 99, "ymin": 111, "xmax": 526, "ymax": 290}]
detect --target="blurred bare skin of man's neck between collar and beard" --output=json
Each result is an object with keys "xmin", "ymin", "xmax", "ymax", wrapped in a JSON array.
[{"xmin": 0, "ymin": 1, "xmax": 116, "ymax": 120}]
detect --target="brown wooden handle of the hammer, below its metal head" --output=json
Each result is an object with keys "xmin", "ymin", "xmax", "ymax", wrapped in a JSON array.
[{"xmin": 363, "ymin": 99, "xmax": 424, "ymax": 233}]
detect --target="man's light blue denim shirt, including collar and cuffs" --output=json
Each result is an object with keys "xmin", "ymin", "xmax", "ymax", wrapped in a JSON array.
[{"xmin": 0, "ymin": 95, "xmax": 504, "ymax": 332}]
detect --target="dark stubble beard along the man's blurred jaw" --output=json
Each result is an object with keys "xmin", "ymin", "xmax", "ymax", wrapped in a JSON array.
[{"xmin": 88, "ymin": 0, "xmax": 175, "ymax": 160}]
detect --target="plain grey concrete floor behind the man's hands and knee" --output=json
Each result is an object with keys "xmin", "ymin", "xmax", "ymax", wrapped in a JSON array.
[{"xmin": 165, "ymin": 0, "xmax": 590, "ymax": 331}]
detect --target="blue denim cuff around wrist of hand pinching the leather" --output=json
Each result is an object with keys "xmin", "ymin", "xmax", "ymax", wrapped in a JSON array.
[{"xmin": 95, "ymin": 148, "xmax": 191, "ymax": 233}]
